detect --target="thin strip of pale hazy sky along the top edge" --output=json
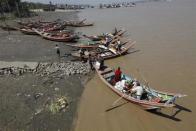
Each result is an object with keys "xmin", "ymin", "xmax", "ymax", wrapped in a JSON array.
[{"xmin": 22, "ymin": 0, "xmax": 133, "ymax": 4}]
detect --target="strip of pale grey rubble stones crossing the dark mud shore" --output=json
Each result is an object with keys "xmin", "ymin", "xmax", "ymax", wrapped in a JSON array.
[{"xmin": 0, "ymin": 61, "xmax": 90, "ymax": 77}]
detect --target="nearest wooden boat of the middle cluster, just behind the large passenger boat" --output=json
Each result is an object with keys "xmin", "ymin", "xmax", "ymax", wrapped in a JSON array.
[{"xmin": 71, "ymin": 41, "xmax": 135, "ymax": 60}]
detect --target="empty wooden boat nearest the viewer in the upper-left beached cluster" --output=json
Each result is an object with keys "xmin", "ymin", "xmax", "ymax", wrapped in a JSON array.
[{"xmin": 33, "ymin": 28, "xmax": 77, "ymax": 42}]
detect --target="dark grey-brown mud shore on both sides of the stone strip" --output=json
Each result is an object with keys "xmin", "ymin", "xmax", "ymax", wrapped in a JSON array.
[{"xmin": 0, "ymin": 12, "xmax": 92, "ymax": 131}]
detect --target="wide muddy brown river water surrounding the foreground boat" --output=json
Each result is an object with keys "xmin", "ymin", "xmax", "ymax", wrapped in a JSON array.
[{"xmin": 75, "ymin": 0, "xmax": 196, "ymax": 131}]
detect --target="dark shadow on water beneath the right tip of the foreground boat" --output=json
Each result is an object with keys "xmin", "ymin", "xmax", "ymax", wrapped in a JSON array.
[{"xmin": 148, "ymin": 104, "xmax": 192, "ymax": 122}]
